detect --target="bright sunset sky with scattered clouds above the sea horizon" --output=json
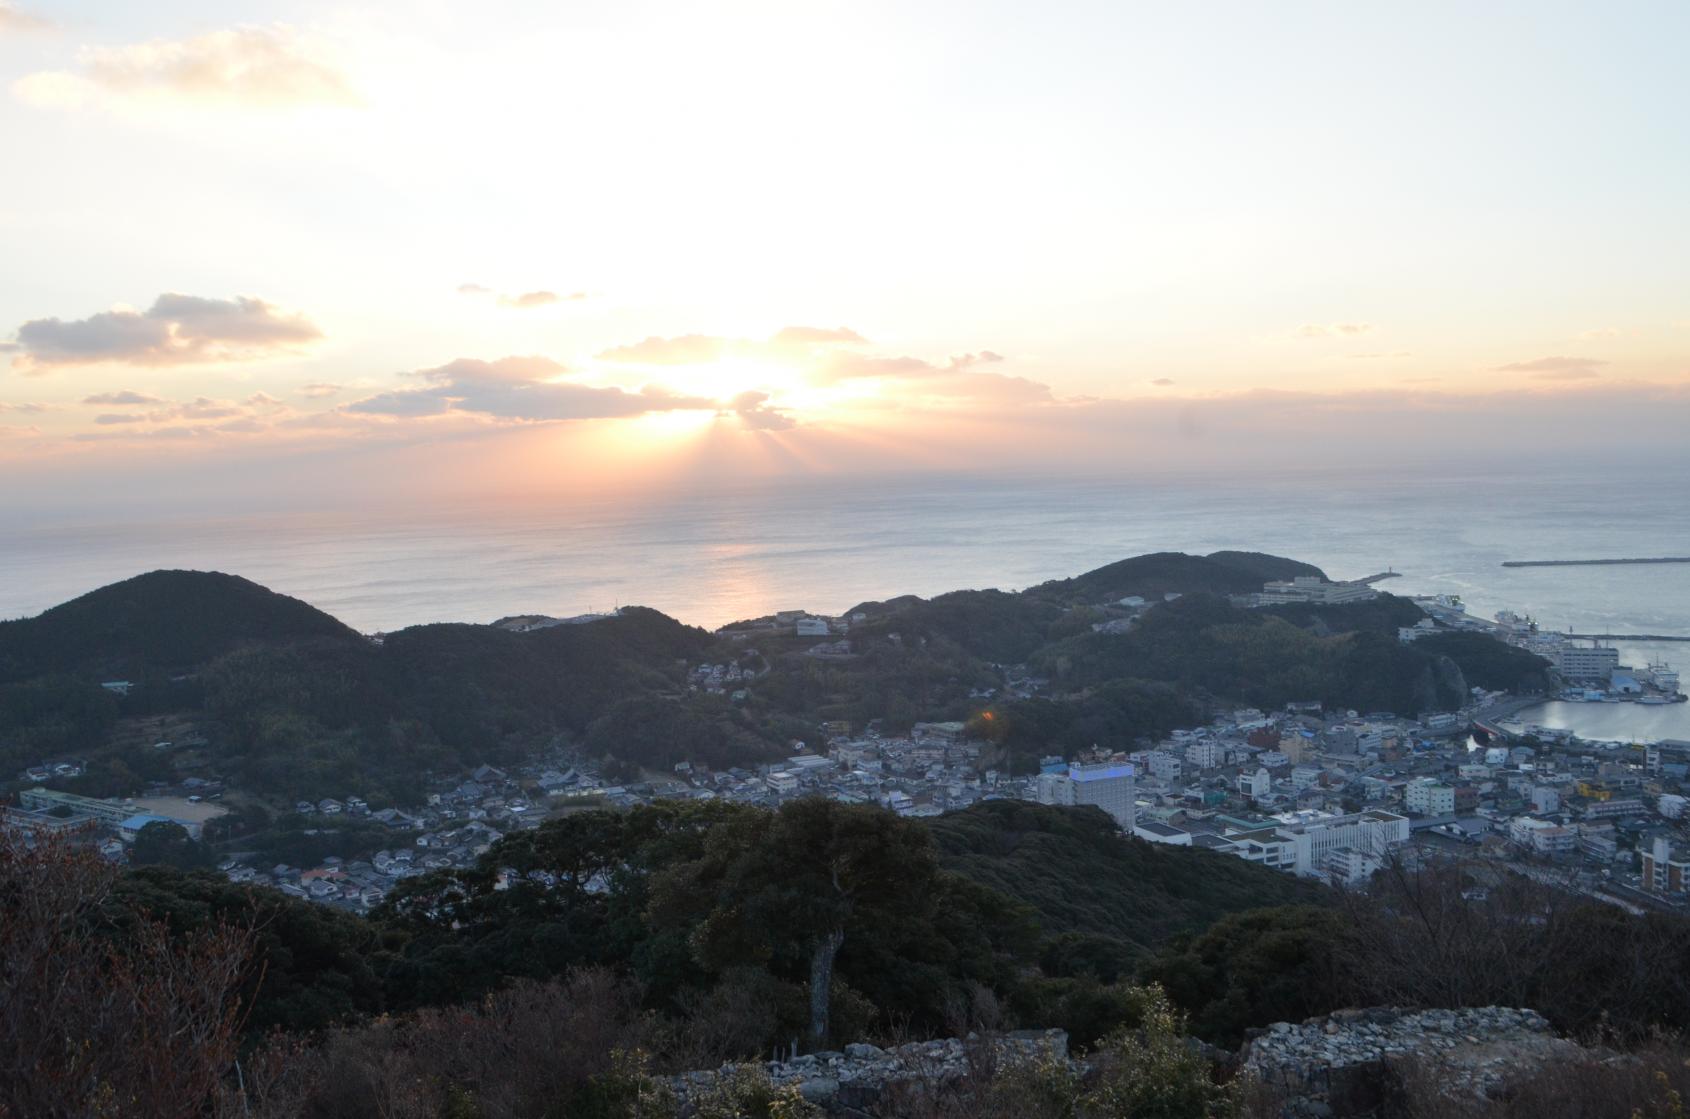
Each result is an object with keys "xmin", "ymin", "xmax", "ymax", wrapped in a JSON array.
[{"xmin": 0, "ymin": 0, "xmax": 1690, "ymax": 510}]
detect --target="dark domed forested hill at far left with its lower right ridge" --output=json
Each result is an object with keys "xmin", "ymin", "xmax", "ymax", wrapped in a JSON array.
[{"xmin": 0, "ymin": 571, "xmax": 723, "ymax": 803}]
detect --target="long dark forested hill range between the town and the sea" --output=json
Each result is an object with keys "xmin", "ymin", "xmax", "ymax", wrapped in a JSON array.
[{"xmin": 0, "ymin": 551, "xmax": 1546, "ymax": 805}]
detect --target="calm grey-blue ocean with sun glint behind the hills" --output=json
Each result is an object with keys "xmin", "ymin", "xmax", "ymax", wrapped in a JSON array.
[{"xmin": 0, "ymin": 467, "xmax": 1690, "ymax": 737}]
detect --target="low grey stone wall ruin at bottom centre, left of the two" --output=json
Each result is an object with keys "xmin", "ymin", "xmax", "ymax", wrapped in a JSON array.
[{"xmin": 671, "ymin": 1029, "xmax": 1068, "ymax": 1116}]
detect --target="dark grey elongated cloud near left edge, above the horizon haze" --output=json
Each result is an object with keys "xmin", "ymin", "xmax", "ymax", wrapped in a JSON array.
[{"xmin": 14, "ymin": 292, "xmax": 323, "ymax": 375}]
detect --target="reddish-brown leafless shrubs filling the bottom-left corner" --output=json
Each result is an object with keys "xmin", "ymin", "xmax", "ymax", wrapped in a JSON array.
[{"xmin": 0, "ymin": 832, "xmax": 252, "ymax": 1119}]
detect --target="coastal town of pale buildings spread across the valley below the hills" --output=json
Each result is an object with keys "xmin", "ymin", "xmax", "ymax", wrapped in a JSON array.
[{"xmin": 0, "ymin": 573, "xmax": 1690, "ymax": 911}]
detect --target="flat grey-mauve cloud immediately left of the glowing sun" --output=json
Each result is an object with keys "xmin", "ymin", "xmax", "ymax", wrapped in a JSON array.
[{"xmin": 341, "ymin": 357, "xmax": 717, "ymax": 423}]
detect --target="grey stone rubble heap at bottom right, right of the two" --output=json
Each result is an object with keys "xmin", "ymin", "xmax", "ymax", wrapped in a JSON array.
[{"xmin": 1242, "ymin": 1006, "xmax": 1584, "ymax": 1117}]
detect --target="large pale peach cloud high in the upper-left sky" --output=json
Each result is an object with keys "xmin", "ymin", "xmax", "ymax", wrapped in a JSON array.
[{"xmin": 12, "ymin": 24, "xmax": 358, "ymax": 108}]
